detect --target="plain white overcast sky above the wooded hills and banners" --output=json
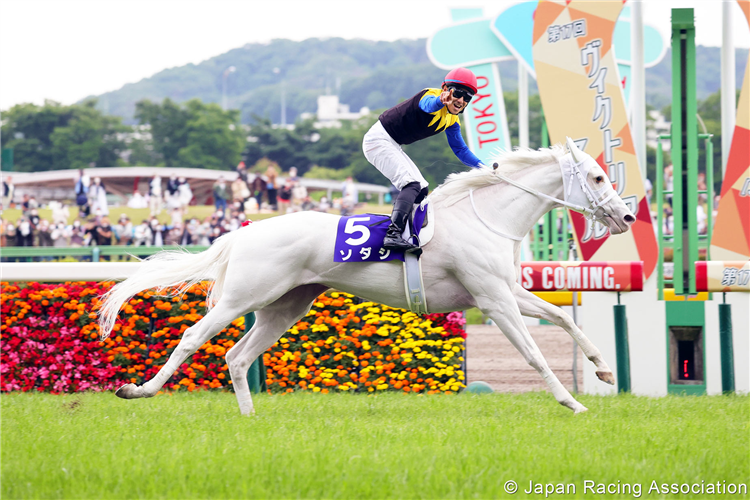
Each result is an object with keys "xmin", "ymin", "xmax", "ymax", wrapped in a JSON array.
[{"xmin": 0, "ymin": 0, "xmax": 750, "ymax": 109}]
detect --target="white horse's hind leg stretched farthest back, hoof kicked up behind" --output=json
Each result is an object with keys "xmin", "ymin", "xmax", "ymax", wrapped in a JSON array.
[{"xmin": 115, "ymin": 298, "xmax": 253, "ymax": 399}]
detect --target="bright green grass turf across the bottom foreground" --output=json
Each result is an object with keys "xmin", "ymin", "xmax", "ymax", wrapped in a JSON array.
[{"xmin": 0, "ymin": 392, "xmax": 750, "ymax": 499}]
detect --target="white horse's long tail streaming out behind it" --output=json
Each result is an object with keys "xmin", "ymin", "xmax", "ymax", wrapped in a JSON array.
[{"xmin": 99, "ymin": 231, "xmax": 240, "ymax": 340}]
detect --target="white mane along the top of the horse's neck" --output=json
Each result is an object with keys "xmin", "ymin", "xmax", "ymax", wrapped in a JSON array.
[{"xmin": 430, "ymin": 144, "xmax": 565, "ymax": 205}]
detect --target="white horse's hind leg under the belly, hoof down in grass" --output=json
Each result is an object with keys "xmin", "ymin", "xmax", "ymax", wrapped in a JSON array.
[{"xmin": 226, "ymin": 285, "xmax": 328, "ymax": 415}]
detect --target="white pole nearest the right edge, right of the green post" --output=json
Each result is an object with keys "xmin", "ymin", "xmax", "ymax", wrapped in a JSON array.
[{"xmin": 721, "ymin": 2, "xmax": 737, "ymax": 179}]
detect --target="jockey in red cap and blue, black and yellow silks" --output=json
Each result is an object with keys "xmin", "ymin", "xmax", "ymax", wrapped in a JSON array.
[{"xmin": 362, "ymin": 68, "xmax": 482, "ymax": 251}]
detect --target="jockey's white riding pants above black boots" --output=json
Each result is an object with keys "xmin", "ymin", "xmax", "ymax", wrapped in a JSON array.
[{"xmin": 362, "ymin": 120, "xmax": 429, "ymax": 189}]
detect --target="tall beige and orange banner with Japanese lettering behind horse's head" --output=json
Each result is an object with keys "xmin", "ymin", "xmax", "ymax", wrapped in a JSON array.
[{"xmin": 533, "ymin": 0, "xmax": 658, "ymax": 278}]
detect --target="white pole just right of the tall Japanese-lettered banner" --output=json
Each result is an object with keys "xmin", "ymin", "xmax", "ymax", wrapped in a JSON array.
[{"xmin": 630, "ymin": 1, "xmax": 647, "ymax": 179}]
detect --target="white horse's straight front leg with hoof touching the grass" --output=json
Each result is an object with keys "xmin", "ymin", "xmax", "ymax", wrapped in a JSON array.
[{"xmin": 464, "ymin": 276, "xmax": 587, "ymax": 413}]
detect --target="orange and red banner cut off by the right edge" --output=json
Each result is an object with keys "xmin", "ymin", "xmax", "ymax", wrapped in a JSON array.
[{"xmin": 711, "ymin": 0, "xmax": 750, "ymax": 261}]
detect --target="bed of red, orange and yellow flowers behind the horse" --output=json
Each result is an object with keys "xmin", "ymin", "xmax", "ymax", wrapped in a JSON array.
[{"xmin": 0, "ymin": 282, "xmax": 465, "ymax": 393}]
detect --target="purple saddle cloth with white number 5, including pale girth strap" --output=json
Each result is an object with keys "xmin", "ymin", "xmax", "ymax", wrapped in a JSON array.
[{"xmin": 333, "ymin": 204, "xmax": 429, "ymax": 314}]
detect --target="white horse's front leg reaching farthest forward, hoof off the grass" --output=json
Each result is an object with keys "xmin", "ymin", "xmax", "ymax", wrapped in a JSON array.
[{"xmin": 513, "ymin": 283, "xmax": 615, "ymax": 385}]
